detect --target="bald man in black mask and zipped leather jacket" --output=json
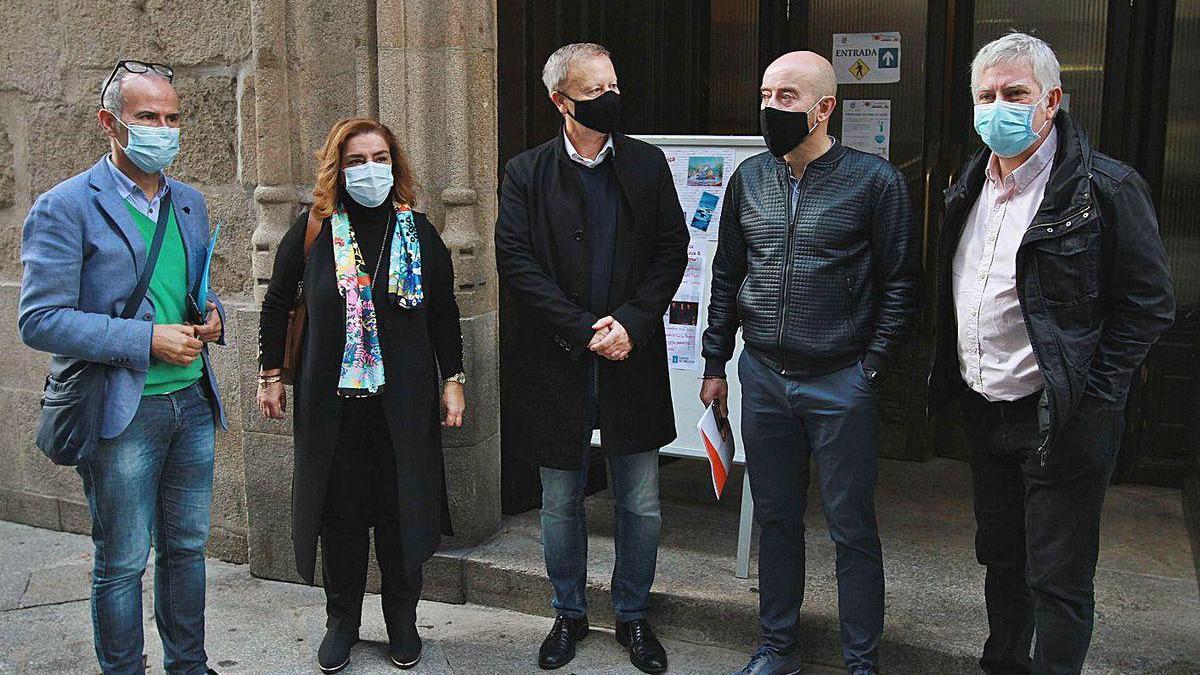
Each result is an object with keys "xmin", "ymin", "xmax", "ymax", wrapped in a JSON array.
[{"xmin": 701, "ymin": 52, "xmax": 919, "ymax": 675}]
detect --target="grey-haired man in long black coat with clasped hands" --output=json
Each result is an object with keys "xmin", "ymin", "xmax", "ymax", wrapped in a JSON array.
[{"xmin": 496, "ymin": 44, "xmax": 688, "ymax": 673}]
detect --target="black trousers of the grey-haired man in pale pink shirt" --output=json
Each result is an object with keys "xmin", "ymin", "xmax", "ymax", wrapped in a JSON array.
[{"xmin": 964, "ymin": 393, "xmax": 1124, "ymax": 675}]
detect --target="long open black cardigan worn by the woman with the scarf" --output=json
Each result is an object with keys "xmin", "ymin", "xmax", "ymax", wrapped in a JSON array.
[{"xmin": 259, "ymin": 198, "xmax": 463, "ymax": 581}]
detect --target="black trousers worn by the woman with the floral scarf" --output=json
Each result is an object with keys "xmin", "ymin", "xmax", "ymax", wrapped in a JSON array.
[{"xmin": 320, "ymin": 398, "xmax": 421, "ymax": 638}]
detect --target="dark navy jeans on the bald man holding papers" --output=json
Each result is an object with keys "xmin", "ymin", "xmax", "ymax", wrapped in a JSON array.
[{"xmin": 738, "ymin": 353, "xmax": 883, "ymax": 673}]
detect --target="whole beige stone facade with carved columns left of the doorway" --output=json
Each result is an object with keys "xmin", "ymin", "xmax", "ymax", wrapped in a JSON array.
[{"xmin": 0, "ymin": 0, "xmax": 499, "ymax": 569}]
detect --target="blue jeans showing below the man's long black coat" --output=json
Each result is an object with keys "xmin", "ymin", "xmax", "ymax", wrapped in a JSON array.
[{"xmin": 541, "ymin": 452, "xmax": 662, "ymax": 621}]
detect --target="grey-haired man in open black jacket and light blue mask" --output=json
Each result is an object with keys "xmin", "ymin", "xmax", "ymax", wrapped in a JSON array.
[{"xmin": 929, "ymin": 34, "xmax": 1175, "ymax": 675}]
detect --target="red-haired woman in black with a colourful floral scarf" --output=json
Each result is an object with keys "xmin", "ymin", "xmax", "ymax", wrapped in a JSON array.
[{"xmin": 258, "ymin": 118, "xmax": 466, "ymax": 673}]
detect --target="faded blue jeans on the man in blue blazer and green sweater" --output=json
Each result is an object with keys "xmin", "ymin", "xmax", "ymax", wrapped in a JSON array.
[{"xmin": 78, "ymin": 381, "xmax": 215, "ymax": 675}]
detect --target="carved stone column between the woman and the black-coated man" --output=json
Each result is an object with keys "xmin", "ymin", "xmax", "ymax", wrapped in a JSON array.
[{"xmin": 376, "ymin": 0, "xmax": 500, "ymax": 546}]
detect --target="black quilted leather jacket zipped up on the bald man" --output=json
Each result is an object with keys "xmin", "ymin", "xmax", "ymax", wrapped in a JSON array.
[{"xmin": 703, "ymin": 141, "xmax": 920, "ymax": 376}]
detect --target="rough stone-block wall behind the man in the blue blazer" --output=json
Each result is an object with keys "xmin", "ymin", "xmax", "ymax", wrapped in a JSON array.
[{"xmin": 0, "ymin": 0, "xmax": 253, "ymax": 561}]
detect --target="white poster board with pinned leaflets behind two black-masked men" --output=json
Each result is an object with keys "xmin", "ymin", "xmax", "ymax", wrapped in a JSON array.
[{"xmin": 593, "ymin": 136, "xmax": 767, "ymax": 464}]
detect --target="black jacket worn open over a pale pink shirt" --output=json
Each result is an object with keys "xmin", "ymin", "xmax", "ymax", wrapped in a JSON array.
[{"xmin": 929, "ymin": 112, "xmax": 1175, "ymax": 461}]
